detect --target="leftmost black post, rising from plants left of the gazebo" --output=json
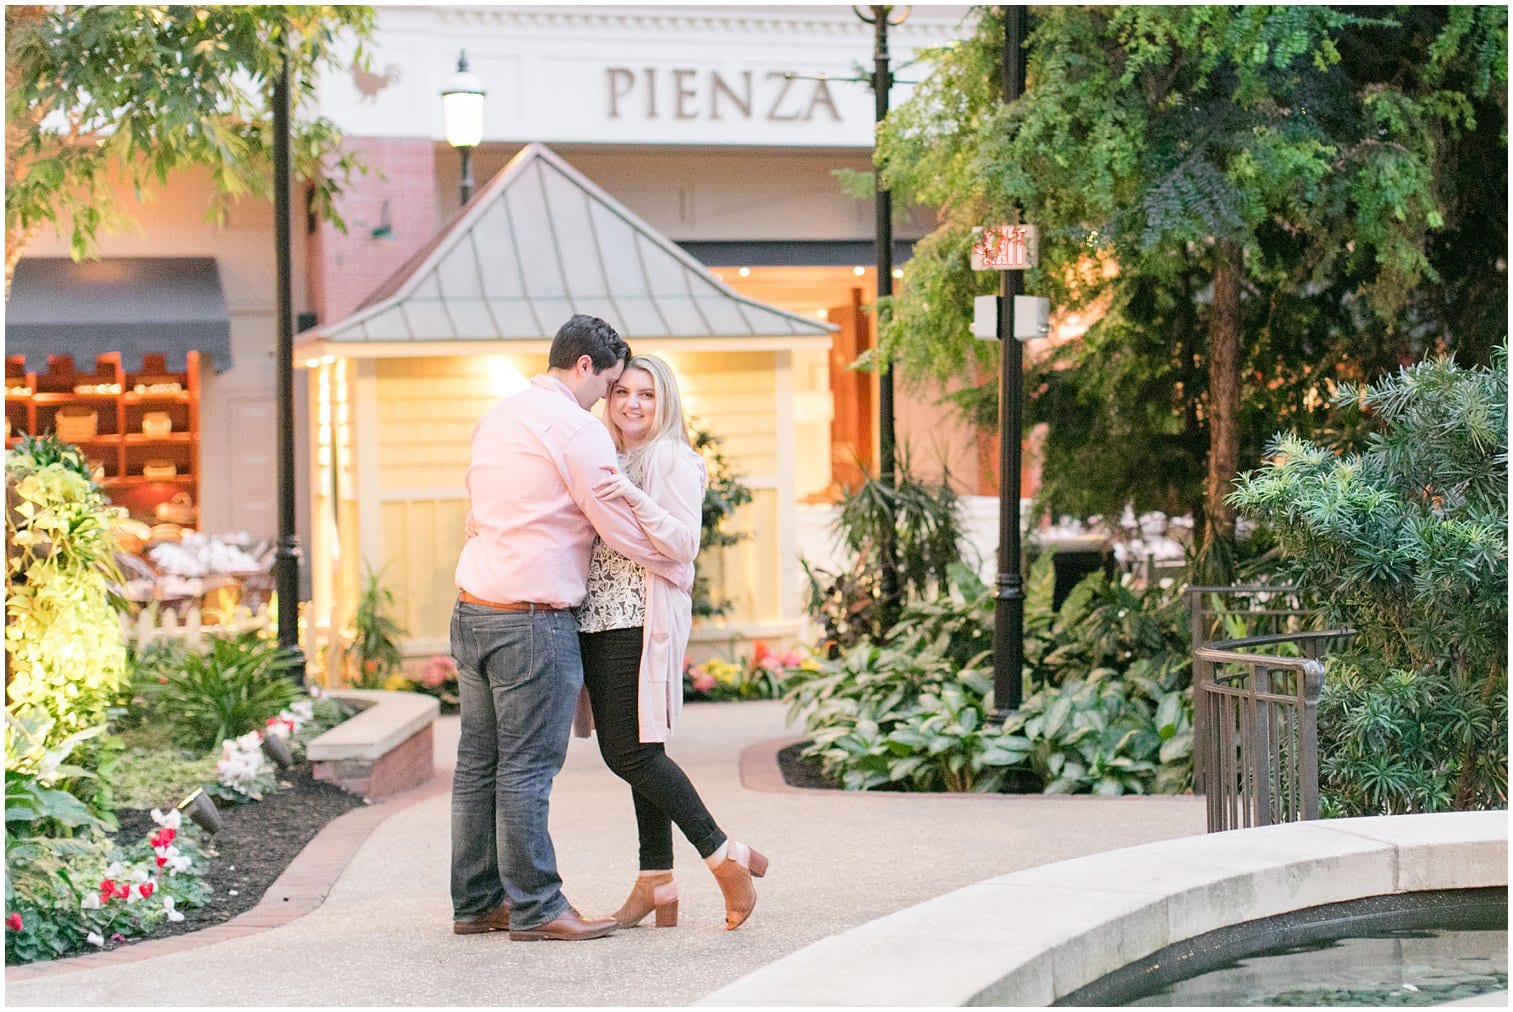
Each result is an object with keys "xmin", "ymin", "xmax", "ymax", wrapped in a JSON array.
[{"xmin": 274, "ymin": 33, "xmax": 304, "ymax": 684}]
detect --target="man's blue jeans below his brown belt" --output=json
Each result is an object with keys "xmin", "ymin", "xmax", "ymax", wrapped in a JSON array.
[{"xmin": 452, "ymin": 602, "xmax": 583, "ymax": 930}]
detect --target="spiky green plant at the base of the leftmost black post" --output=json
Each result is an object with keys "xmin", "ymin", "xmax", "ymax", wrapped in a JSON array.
[{"xmin": 142, "ymin": 632, "xmax": 301, "ymax": 752}]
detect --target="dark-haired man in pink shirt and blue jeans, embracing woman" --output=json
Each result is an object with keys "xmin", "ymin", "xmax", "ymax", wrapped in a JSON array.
[{"xmin": 451, "ymin": 313, "xmax": 693, "ymax": 941}]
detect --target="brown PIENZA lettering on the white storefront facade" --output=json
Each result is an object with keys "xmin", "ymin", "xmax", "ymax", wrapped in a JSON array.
[{"xmin": 605, "ymin": 67, "xmax": 841, "ymax": 123}]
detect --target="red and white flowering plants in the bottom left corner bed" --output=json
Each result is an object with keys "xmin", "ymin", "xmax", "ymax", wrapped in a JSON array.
[{"xmin": 5, "ymin": 809, "xmax": 210, "ymax": 965}]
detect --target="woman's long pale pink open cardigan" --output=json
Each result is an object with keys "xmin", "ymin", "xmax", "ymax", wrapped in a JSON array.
[{"xmin": 573, "ymin": 439, "xmax": 710, "ymax": 741}]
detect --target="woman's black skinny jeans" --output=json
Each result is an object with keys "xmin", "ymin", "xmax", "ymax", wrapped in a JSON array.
[{"xmin": 578, "ymin": 626, "xmax": 725, "ymax": 871}]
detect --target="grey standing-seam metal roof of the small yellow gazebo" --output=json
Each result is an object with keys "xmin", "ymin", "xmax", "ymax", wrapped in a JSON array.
[{"xmin": 300, "ymin": 144, "xmax": 834, "ymax": 354}]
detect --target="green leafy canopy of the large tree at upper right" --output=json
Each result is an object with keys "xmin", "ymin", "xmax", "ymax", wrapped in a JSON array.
[{"xmin": 878, "ymin": 5, "xmax": 1508, "ymax": 535}]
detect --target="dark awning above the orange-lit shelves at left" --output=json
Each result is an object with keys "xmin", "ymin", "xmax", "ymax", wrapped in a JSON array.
[{"xmin": 5, "ymin": 257, "xmax": 231, "ymax": 372}]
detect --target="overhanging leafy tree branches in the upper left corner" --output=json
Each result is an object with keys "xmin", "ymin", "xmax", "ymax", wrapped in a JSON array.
[{"xmin": 5, "ymin": 5, "xmax": 372, "ymax": 298}]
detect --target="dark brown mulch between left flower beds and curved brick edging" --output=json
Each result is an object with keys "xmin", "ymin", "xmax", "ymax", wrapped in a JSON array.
[{"xmin": 106, "ymin": 762, "xmax": 365, "ymax": 948}]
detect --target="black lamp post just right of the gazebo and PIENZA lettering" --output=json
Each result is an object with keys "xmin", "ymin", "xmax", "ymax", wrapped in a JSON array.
[{"xmin": 852, "ymin": 5, "xmax": 911, "ymax": 626}]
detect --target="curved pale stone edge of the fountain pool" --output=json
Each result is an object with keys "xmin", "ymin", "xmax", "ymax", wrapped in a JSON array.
[{"xmin": 699, "ymin": 811, "xmax": 1508, "ymax": 1006}]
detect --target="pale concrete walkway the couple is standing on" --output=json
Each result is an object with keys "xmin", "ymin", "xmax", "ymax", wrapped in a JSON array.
[{"xmin": 6, "ymin": 702, "xmax": 1204, "ymax": 1007}]
